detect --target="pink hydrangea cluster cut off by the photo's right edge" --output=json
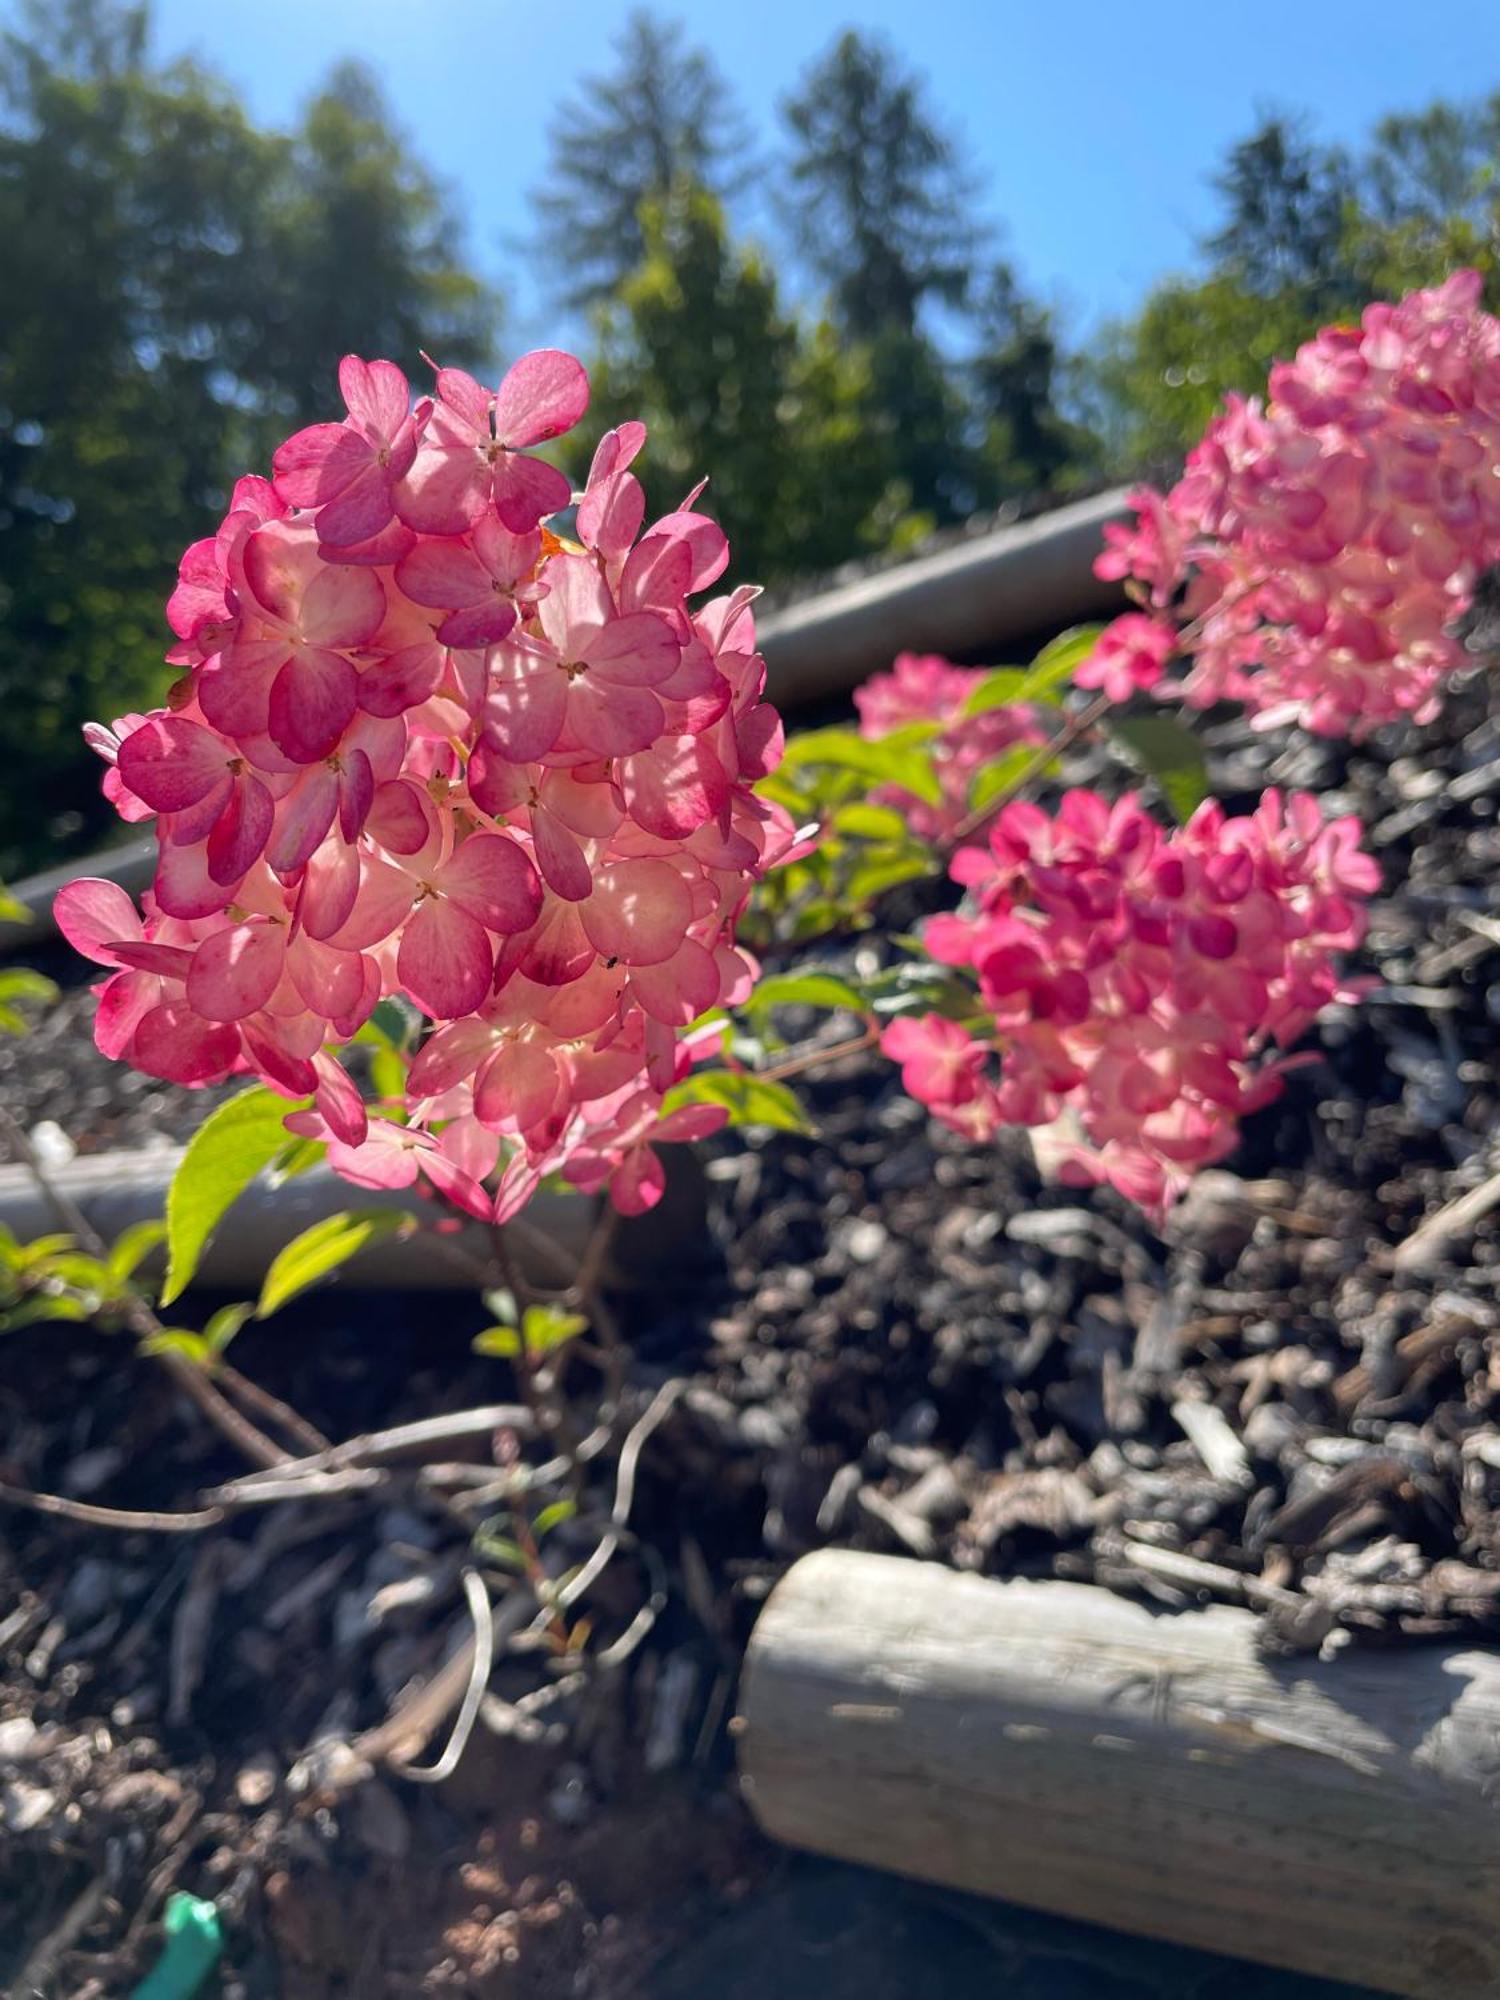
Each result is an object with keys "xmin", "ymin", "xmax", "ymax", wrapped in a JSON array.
[{"xmin": 1076, "ymin": 272, "xmax": 1500, "ymax": 736}]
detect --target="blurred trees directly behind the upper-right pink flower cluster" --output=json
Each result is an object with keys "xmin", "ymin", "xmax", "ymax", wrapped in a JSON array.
[{"xmin": 1088, "ymin": 107, "xmax": 1500, "ymax": 474}]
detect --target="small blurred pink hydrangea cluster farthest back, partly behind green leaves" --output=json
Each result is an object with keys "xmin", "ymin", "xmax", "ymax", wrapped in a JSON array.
[{"xmin": 854, "ymin": 652, "xmax": 1046, "ymax": 842}]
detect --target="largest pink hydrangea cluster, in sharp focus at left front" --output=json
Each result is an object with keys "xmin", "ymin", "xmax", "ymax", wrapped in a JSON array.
[{"xmin": 58, "ymin": 350, "xmax": 792, "ymax": 1218}]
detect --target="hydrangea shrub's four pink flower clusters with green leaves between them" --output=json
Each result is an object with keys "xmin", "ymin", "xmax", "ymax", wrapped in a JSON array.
[{"xmin": 41, "ymin": 274, "xmax": 1500, "ymax": 1272}]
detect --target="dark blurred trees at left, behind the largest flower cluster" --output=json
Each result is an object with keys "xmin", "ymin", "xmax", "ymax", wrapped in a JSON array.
[{"xmin": 0, "ymin": 0, "xmax": 492, "ymax": 872}]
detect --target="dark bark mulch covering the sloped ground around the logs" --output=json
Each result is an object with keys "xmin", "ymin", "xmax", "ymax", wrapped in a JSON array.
[{"xmin": 0, "ymin": 684, "xmax": 1500, "ymax": 2000}]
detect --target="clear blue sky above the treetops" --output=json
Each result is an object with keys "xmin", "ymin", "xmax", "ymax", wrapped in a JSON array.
[{"xmin": 129, "ymin": 0, "xmax": 1500, "ymax": 344}]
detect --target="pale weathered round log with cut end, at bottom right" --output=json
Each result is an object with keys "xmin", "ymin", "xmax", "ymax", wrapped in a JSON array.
[{"xmin": 738, "ymin": 1550, "xmax": 1500, "ymax": 2000}]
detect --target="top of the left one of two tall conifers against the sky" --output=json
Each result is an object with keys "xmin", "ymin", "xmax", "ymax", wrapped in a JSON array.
[{"xmin": 532, "ymin": 10, "xmax": 748, "ymax": 306}]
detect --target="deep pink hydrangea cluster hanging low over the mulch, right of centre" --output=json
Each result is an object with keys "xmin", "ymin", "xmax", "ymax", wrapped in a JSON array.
[{"xmin": 882, "ymin": 790, "xmax": 1380, "ymax": 1214}]
